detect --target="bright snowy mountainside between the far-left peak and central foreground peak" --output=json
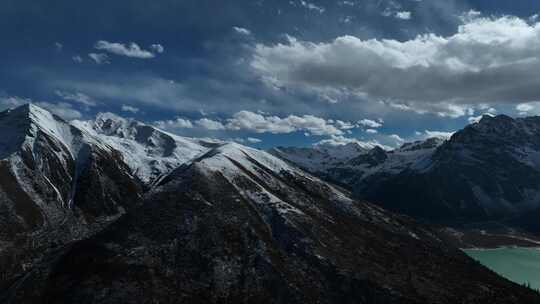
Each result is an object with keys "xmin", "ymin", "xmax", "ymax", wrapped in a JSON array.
[{"xmin": 74, "ymin": 113, "xmax": 218, "ymax": 184}]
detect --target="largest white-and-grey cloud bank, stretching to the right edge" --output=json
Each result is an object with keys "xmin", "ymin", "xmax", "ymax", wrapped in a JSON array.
[{"xmin": 251, "ymin": 12, "xmax": 540, "ymax": 111}]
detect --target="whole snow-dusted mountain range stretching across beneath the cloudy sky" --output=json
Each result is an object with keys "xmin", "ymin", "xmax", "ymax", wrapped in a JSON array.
[{"xmin": 0, "ymin": 104, "xmax": 540, "ymax": 303}]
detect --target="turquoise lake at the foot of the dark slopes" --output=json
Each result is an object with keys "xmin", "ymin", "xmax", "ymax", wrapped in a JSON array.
[{"xmin": 464, "ymin": 248, "xmax": 540, "ymax": 289}]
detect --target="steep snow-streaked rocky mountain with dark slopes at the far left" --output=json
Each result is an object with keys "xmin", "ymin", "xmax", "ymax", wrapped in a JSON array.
[{"xmin": 0, "ymin": 105, "xmax": 142, "ymax": 288}]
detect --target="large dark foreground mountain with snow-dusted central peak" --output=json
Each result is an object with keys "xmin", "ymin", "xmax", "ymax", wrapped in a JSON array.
[{"xmin": 4, "ymin": 144, "xmax": 538, "ymax": 303}]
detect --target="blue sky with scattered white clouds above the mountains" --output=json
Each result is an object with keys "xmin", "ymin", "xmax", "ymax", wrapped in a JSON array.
[{"xmin": 0, "ymin": 0, "xmax": 540, "ymax": 148}]
